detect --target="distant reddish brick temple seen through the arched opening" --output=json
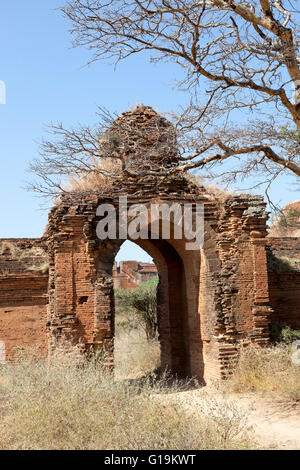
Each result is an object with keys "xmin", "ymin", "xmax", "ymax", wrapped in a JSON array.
[{"xmin": 113, "ymin": 261, "xmax": 158, "ymax": 289}]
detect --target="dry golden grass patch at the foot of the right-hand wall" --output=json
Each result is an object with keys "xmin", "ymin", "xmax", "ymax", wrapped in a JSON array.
[{"xmin": 226, "ymin": 344, "xmax": 300, "ymax": 402}]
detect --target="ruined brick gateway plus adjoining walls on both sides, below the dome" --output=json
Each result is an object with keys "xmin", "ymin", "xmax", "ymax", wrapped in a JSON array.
[{"xmin": 0, "ymin": 107, "xmax": 300, "ymax": 382}]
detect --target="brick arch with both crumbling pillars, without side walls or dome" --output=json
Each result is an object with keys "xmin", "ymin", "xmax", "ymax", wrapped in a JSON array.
[{"xmin": 47, "ymin": 188, "xmax": 270, "ymax": 382}]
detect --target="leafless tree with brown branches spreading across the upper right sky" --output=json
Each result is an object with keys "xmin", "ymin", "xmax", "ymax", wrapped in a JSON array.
[{"xmin": 31, "ymin": 0, "xmax": 300, "ymax": 199}]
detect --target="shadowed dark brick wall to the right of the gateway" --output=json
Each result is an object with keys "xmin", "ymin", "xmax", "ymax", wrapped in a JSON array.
[{"xmin": 267, "ymin": 237, "xmax": 300, "ymax": 329}]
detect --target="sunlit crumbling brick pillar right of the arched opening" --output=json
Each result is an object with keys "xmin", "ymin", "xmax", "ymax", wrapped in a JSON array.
[{"xmin": 199, "ymin": 195, "xmax": 271, "ymax": 381}]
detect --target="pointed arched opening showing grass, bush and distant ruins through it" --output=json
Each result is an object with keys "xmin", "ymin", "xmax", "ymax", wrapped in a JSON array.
[{"xmin": 113, "ymin": 240, "xmax": 160, "ymax": 379}]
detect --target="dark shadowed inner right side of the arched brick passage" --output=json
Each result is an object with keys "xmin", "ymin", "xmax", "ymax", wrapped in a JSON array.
[{"xmin": 127, "ymin": 213, "xmax": 203, "ymax": 381}]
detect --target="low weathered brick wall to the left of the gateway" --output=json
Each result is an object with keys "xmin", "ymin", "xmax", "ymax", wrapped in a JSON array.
[{"xmin": 0, "ymin": 239, "xmax": 48, "ymax": 360}]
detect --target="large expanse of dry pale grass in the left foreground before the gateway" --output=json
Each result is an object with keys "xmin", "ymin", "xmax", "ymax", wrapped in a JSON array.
[{"xmin": 0, "ymin": 351, "xmax": 250, "ymax": 450}]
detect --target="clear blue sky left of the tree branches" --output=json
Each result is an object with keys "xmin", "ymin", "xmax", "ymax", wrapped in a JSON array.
[{"xmin": 0, "ymin": 0, "xmax": 299, "ymax": 261}]
